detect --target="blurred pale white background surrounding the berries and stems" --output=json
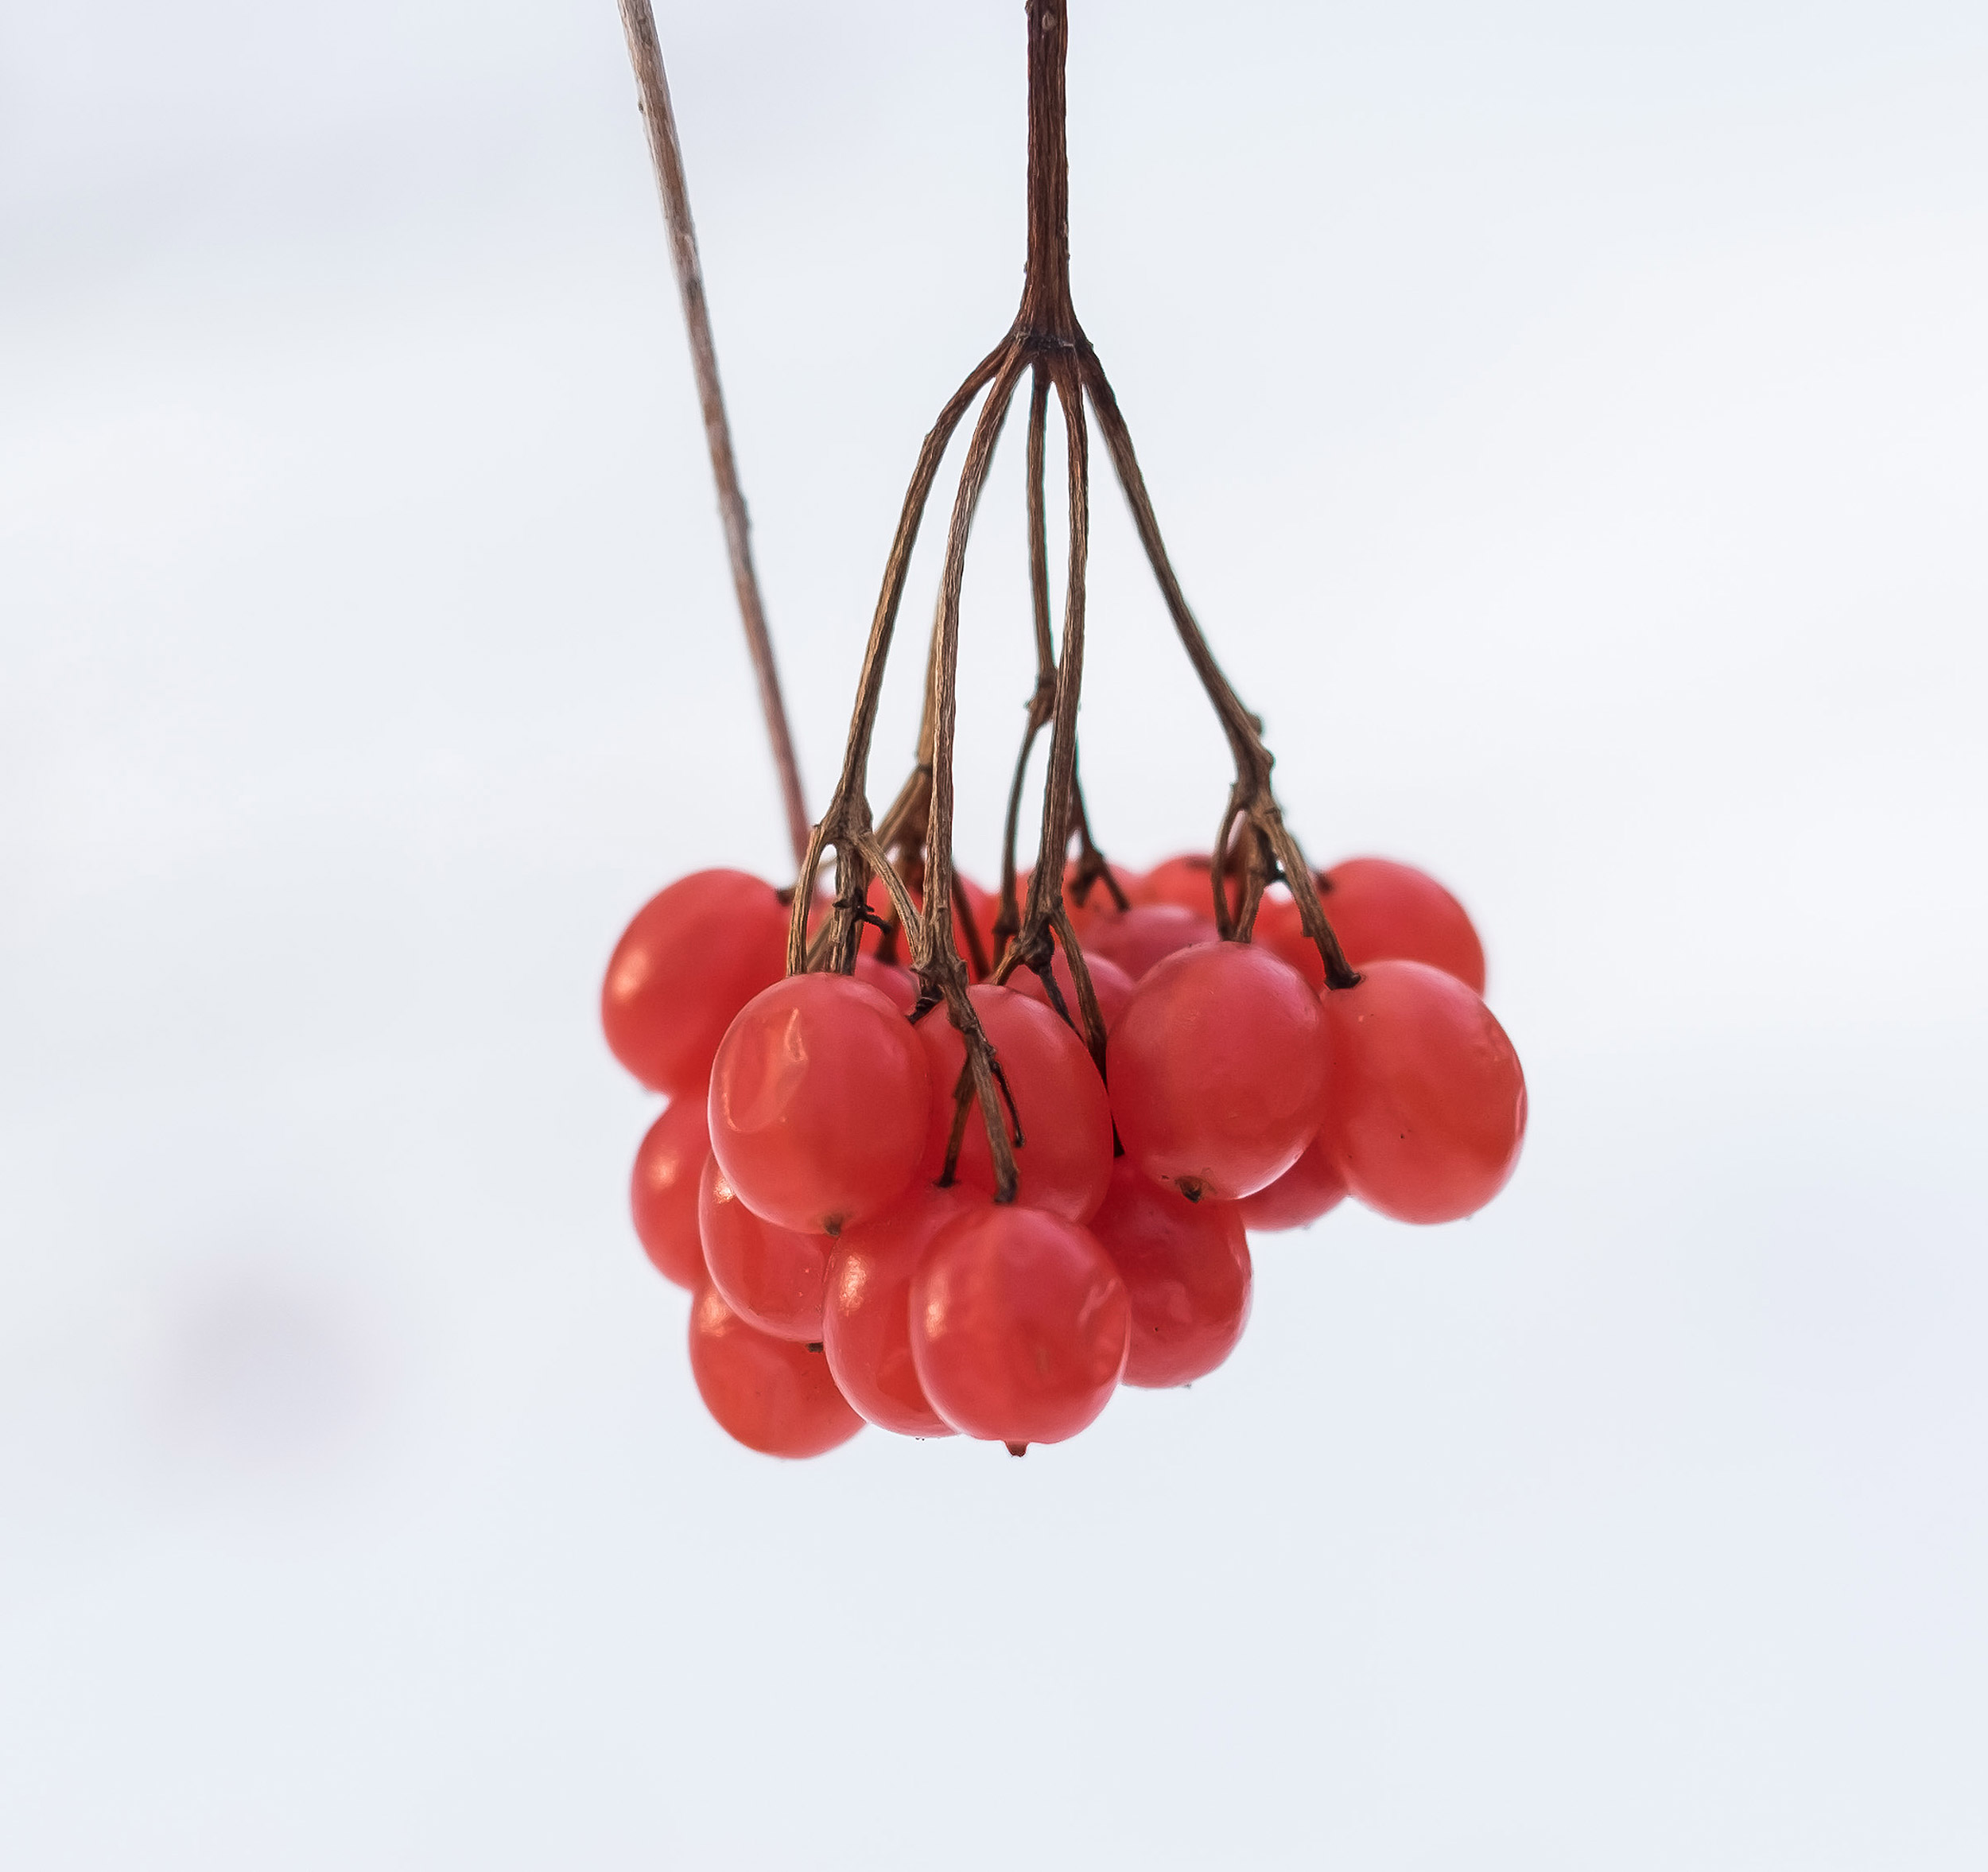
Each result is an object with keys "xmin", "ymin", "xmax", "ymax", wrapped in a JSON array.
[{"xmin": 0, "ymin": 0, "xmax": 1988, "ymax": 1872}]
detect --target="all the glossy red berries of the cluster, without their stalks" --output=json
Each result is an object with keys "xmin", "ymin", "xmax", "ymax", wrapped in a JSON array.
[{"xmin": 600, "ymin": 859, "xmax": 1525, "ymax": 1457}]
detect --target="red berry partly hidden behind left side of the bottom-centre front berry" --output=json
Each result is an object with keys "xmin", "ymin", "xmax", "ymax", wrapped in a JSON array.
[{"xmin": 821, "ymin": 1183, "xmax": 986, "ymax": 1437}]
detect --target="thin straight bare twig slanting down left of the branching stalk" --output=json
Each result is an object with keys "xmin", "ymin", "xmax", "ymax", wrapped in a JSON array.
[{"xmin": 620, "ymin": 0, "xmax": 807, "ymax": 864}]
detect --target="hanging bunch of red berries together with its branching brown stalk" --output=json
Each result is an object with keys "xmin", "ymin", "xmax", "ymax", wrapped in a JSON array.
[{"xmin": 603, "ymin": 0, "xmax": 1527, "ymax": 1457}]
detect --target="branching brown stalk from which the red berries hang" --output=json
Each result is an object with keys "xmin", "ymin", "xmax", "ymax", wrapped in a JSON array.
[{"xmin": 775, "ymin": 0, "xmax": 1360, "ymax": 1202}]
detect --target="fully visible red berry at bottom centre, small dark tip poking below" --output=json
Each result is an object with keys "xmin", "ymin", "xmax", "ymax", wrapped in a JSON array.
[{"xmin": 911, "ymin": 1204, "xmax": 1132, "ymax": 1445}]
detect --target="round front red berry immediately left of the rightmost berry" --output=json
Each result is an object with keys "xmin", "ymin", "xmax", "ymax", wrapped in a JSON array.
[{"xmin": 1112, "ymin": 942, "xmax": 1326, "ymax": 1198}]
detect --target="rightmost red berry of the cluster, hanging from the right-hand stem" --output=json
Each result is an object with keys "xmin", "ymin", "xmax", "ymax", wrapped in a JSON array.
[{"xmin": 1322, "ymin": 961, "xmax": 1525, "ymax": 1222}]
